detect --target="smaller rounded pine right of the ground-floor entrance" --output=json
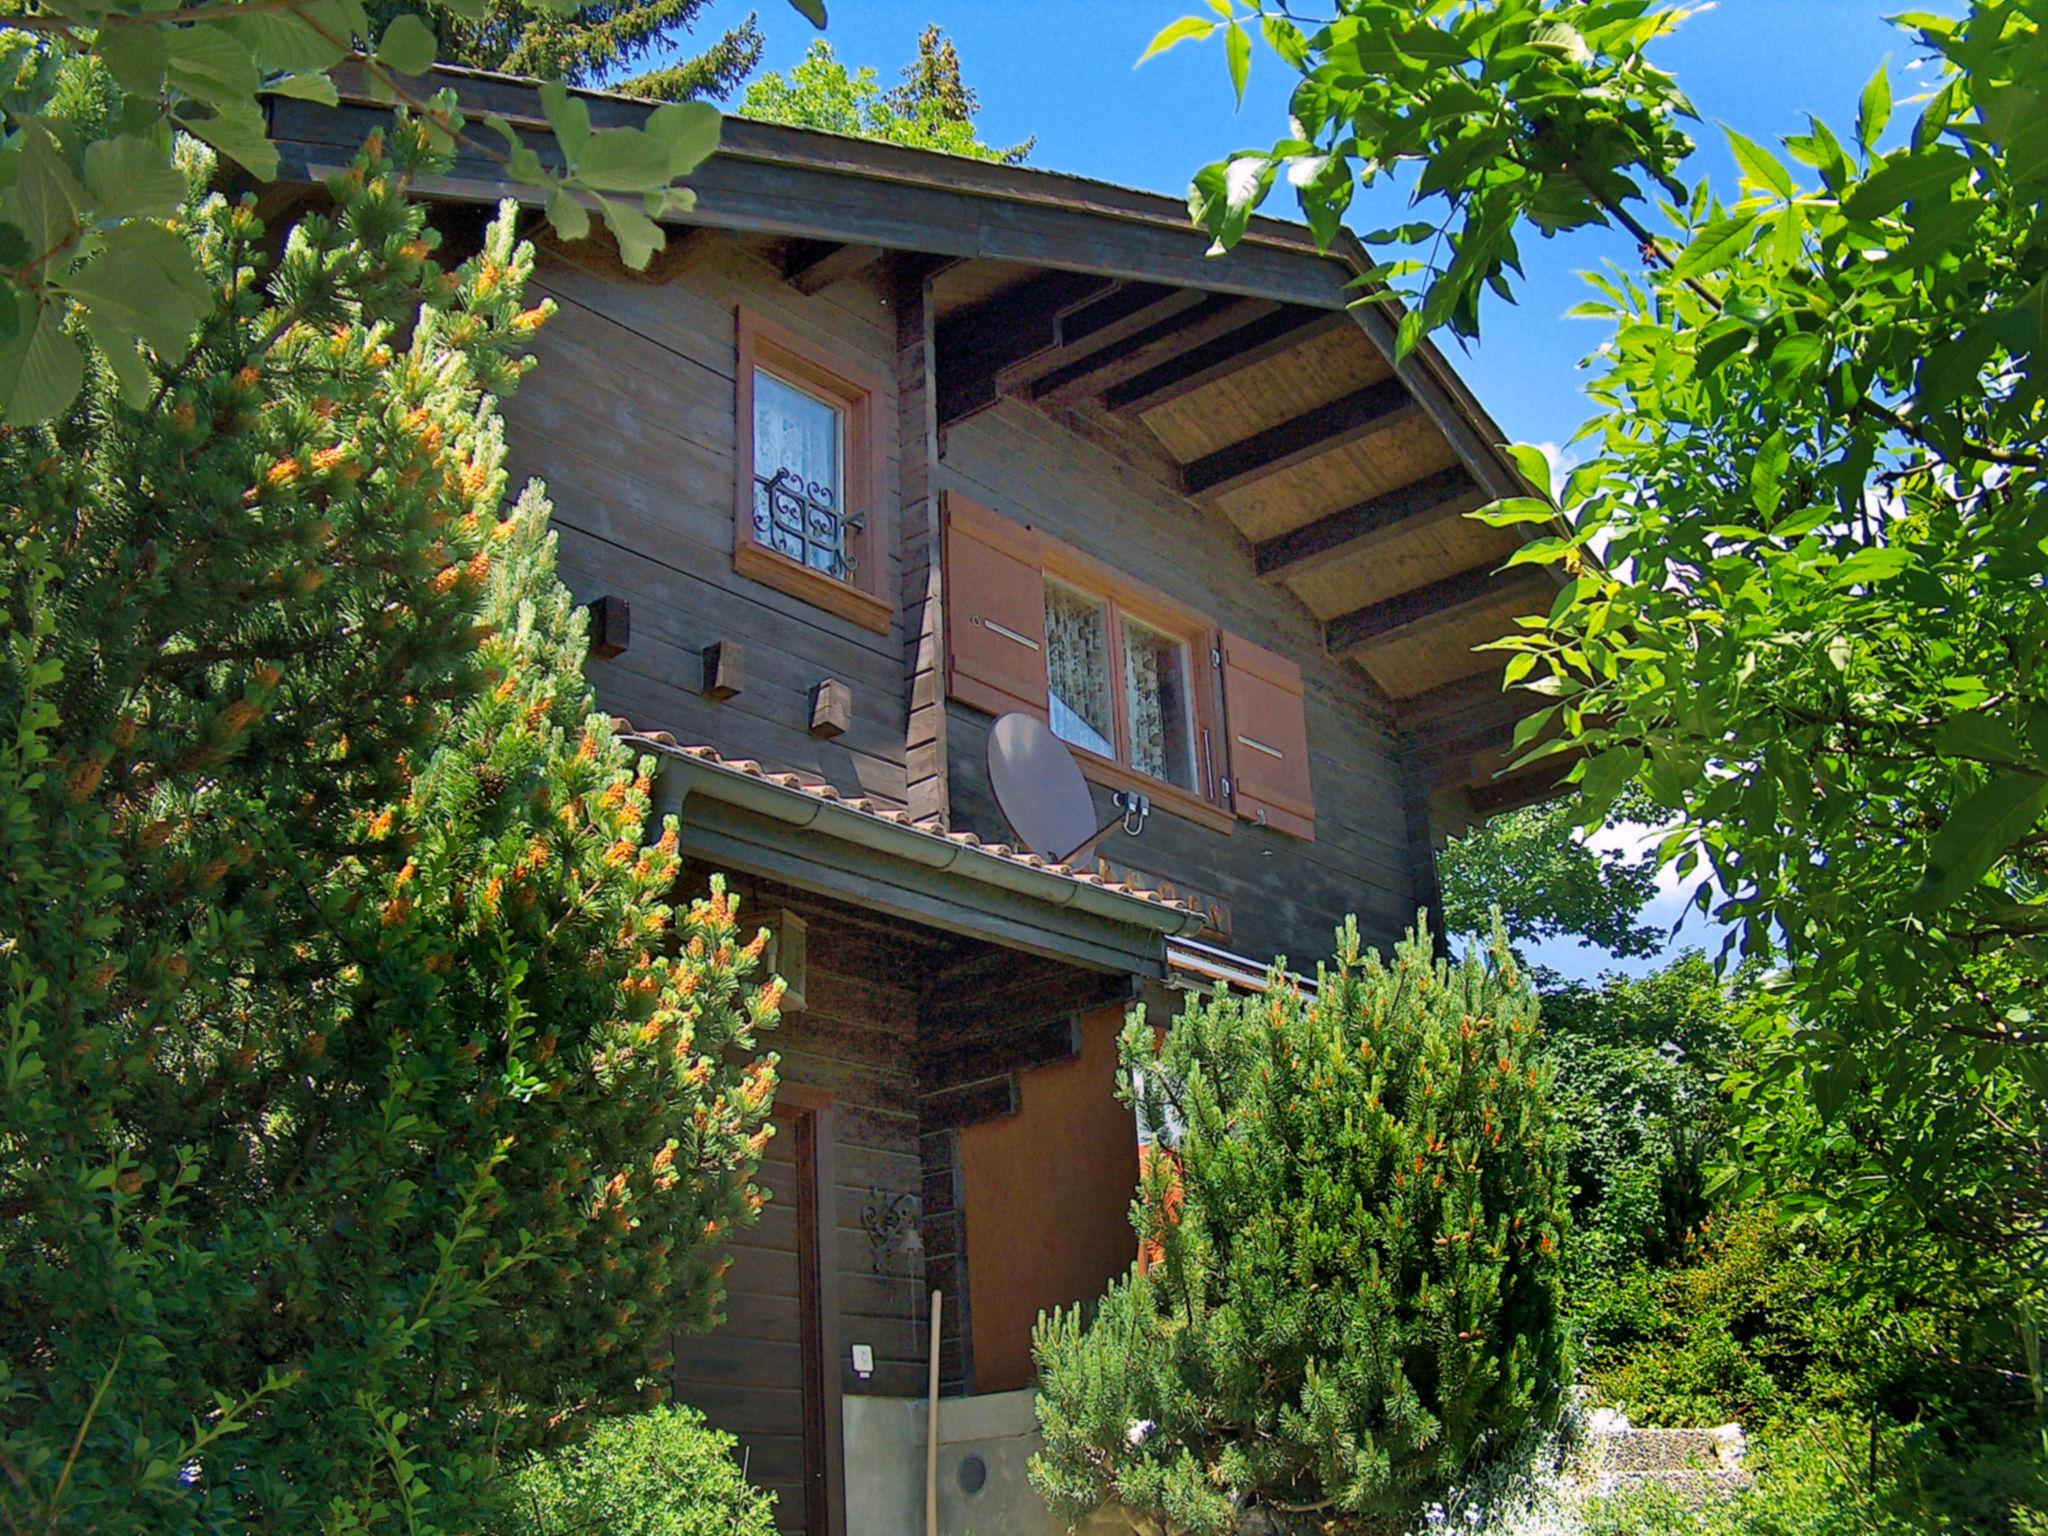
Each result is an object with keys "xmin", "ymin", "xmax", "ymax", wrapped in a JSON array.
[{"xmin": 1032, "ymin": 924, "xmax": 1565, "ymax": 1536}]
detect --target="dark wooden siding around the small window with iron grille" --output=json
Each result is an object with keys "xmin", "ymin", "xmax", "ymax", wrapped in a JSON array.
[{"xmin": 506, "ymin": 236, "xmax": 907, "ymax": 805}]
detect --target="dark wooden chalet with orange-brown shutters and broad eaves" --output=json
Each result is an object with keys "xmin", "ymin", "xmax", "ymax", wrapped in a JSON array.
[{"xmin": 270, "ymin": 72, "xmax": 1554, "ymax": 1536}]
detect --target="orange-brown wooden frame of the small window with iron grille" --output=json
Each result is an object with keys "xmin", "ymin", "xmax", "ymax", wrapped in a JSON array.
[{"xmin": 733, "ymin": 309, "xmax": 895, "ymax": 635}]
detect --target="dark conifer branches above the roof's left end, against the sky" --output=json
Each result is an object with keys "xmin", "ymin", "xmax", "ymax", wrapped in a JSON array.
[{"xmin": 369, "ymin": 0, "xmax": 766, "ymax": 100}]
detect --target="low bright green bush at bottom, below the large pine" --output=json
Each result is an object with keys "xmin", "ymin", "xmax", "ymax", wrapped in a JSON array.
[{"xmin": 504, "ymin": 1407, "xmax": 774, "ymax": 1536}]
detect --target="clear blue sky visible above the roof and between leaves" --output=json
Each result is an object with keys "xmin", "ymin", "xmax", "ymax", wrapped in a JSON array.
[{"xmin": 671, "ymin": 0, "xmax": 1958, "ymax": 975}]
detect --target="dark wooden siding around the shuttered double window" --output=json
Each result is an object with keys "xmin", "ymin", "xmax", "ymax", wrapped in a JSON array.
[{"xmin": 938, "ymin": 399, "xmax": 1425, "ymax": 965}]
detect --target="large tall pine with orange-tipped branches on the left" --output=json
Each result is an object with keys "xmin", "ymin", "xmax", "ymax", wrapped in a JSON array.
[{"xmin": 0, "ymin": 117, "xmax": 778, "ymax": 1534}]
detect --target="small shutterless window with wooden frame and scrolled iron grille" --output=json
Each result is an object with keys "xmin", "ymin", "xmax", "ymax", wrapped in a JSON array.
[{"xmin": 733, "ymin": 309, "xmax": 893, "ymax": 633}]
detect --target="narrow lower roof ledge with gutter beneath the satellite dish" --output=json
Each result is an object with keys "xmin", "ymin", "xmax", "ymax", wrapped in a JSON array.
[{"xmin": 647, "ymin": 737, "xmax": 1206, "ymax": 979}]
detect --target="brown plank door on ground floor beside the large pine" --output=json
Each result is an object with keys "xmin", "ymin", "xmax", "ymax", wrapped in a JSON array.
[{"xmin": 676, "ymin": 1090, "xmax": 834, "ymax": 1536}]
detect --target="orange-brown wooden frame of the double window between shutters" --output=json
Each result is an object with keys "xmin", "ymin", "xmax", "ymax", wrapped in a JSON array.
[{"xmin": 1040, "ymin": 539, "xmax": 1237, "ymax": 834}]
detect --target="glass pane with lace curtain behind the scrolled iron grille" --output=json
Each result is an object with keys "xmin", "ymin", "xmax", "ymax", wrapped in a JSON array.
[{"xmin": 754, "ymin": 369, "xmax": 854, "ymax": 580}]
